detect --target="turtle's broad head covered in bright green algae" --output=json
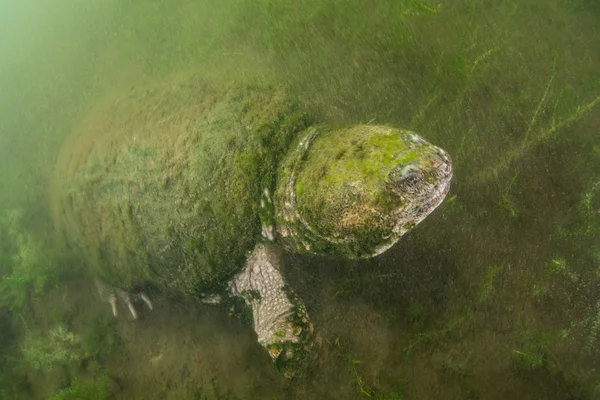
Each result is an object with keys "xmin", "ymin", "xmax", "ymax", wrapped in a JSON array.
[{"xmin": 275, "ymin": 125, "xmax": 452, "ymax": 258}]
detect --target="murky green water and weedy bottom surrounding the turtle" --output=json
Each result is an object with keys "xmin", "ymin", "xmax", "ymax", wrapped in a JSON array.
[{"xmin": 0, "ymin": 0, "xmax": 600, "ymax": 399}]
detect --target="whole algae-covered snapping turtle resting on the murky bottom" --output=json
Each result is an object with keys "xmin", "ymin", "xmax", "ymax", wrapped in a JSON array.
[{"xmin": 53, "ymin": 75, "xmax": 452, "ymax": 372}]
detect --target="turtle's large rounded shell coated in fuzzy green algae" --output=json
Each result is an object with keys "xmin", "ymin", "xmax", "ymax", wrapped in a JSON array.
[{"xmin": 53, "ymin": 76, "xmax": 307, "ymax": 293}]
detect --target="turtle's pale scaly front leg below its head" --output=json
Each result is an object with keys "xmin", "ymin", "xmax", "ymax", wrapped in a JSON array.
[{"xmin": 229, "ymin": 244, "xmax": 313, "ymax": 378}]
